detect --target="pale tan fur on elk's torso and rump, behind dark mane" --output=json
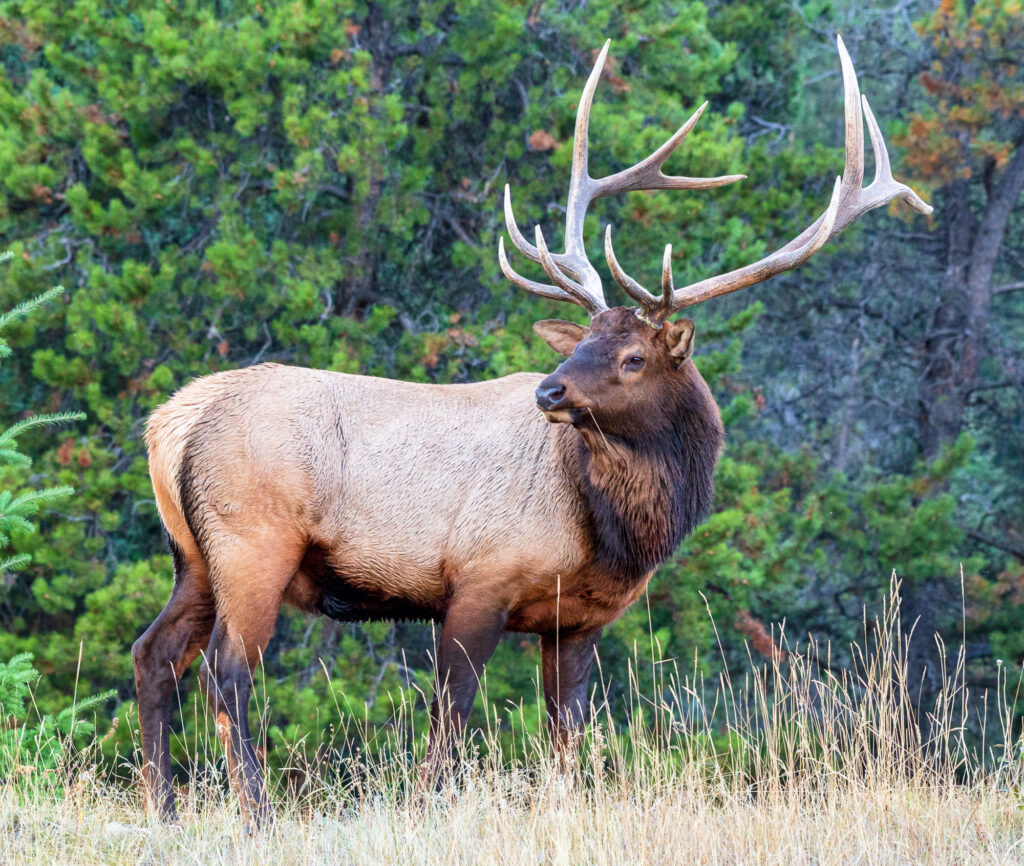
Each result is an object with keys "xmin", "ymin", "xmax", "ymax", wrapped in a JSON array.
[{"xmin": 146, "ymin": 364, "xmax": 646, "ymax": 650}]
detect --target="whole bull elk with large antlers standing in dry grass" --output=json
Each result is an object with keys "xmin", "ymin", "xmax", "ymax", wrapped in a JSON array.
[{"xmin": 132, "ymin": 40, "xmax": 931, "ymax": 823}]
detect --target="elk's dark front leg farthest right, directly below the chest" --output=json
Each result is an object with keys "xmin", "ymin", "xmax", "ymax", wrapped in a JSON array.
[{"xmin": 541, "ymin": 629, "xmax": 601, "ymax": 767}]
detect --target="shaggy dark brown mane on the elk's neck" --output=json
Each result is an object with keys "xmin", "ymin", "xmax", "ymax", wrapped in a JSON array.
[{"xmin": 566, "ymin": 369, "xmax": 723, "ymax": 582}]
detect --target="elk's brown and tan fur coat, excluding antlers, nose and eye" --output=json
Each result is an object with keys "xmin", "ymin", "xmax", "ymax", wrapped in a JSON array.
[{"xmin": 134, "ymin": 309, "xmax": 722, "ymax": 818}]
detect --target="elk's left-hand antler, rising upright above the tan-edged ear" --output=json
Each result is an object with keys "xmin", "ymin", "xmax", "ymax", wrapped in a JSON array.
[{"xmin": 498, "ymin": 40, "xmax": 744, "ymax": 316}]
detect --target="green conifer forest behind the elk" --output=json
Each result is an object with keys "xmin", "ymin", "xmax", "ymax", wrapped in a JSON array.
[{"xmin": 0, "ymin": 0, "xmax": 1024, "ymax": 773}]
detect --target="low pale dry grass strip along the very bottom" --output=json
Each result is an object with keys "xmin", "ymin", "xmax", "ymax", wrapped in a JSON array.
[{"xmin": 0, "ymin": 772, "xmax": 1024, "ymax": 864}]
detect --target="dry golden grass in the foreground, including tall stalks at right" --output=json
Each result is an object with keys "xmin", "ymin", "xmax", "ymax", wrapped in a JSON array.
[{"xmin": 0, "ymin": 581, "xmax": 1024, "ymax": 866}]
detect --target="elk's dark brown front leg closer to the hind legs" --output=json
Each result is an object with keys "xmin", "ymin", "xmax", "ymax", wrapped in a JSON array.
[{"xmin": 421, "ymin": 600, "xmax": 507, "ymax": 787}]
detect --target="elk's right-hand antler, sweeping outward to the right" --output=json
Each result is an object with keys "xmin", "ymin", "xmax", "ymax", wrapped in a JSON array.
[{"xmin": 604, "ymin": 36, "xmax": 932, "ymax": 327}]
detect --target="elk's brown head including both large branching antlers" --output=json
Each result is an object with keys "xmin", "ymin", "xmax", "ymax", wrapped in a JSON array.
[{"xmin": 498, "ymin": 37, "xmax": 932, "ymax": 432}]
